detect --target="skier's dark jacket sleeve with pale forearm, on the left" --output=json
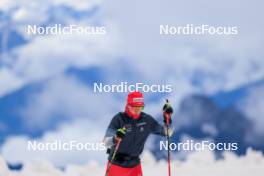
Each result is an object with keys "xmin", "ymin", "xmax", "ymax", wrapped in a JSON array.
[{"xmin": 103, "ymin": 114, "xmax": 120, "ymax": 148}]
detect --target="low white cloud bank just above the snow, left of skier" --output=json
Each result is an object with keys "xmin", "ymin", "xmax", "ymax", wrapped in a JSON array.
[{"xmin": 1, "ymin": 119, "xmax": 107, "ymax": 167}]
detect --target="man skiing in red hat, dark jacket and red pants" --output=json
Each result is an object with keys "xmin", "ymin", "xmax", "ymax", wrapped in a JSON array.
[{"xmin": 104, "ymin": 91, "xmax": 173, "ymax": 176}]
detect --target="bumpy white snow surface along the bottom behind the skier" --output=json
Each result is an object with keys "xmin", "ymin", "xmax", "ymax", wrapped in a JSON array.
[{"xmin": 0, "ymin": 149, "xmax": 264, "ymax": 176}]
